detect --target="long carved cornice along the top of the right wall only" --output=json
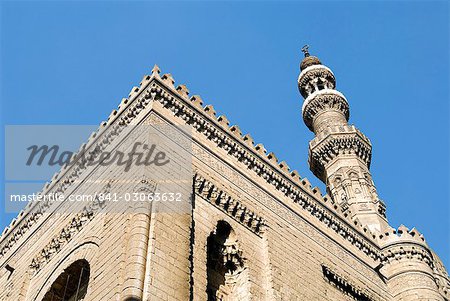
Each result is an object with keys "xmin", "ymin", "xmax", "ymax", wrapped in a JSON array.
[{"xmin": 156, "ymin": 80, "xmax": 379, "ymax": 260}]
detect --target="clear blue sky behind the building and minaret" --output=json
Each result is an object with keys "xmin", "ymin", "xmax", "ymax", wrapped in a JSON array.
[{"xmin": 0, "ymin": 1, "xmax": 450, "ymax": 267}]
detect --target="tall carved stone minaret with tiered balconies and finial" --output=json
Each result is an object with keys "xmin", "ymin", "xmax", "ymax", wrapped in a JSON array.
[{"xmin": 298, "ymin": 46, "xmax": 388, "ymax": 231}]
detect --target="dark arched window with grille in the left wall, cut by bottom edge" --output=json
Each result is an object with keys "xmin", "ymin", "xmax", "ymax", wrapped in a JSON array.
[{"xmin": 42, "ymin": 259, "xmax": 90, "ymax": 301}]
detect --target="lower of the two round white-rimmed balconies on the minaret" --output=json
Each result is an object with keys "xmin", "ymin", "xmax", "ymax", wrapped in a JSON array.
[{"xmin": 302, "ymin": 89, "xmax": 350, "ymax": 131}]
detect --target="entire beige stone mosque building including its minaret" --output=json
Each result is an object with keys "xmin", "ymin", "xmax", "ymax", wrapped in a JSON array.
[{"xmin": 0, "ymin": 53, "xmax": 450, "ymax": 301}]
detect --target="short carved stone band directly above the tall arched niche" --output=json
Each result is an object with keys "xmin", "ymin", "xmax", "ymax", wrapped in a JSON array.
[{"xmin": 194, "ymin": 174, "xmax": 266, "ymax": 236}]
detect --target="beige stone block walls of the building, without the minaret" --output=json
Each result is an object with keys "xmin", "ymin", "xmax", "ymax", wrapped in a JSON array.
[{"xmin": 0, "ymin": 70, "xmax": 448, "ymax": 301}]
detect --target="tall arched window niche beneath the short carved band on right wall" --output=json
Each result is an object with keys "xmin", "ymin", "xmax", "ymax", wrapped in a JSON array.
[{"xmin": 206, "ymin": 221, "xmax": 249, "ymax": 301}]
